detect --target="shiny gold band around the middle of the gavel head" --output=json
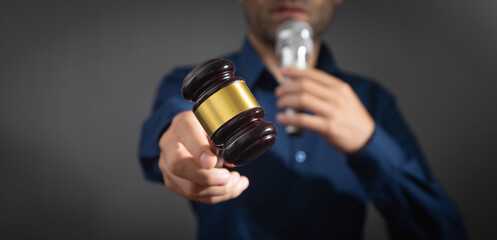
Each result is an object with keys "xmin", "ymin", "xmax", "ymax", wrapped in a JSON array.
[{"xmin": 194, "ymin": 81, "xmax": 260, "ymax": 137}]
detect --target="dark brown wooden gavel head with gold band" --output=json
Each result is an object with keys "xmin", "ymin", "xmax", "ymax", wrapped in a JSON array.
[{"xmin": 181, "ymin": 58, "xmax": 276, "ymax": 166}]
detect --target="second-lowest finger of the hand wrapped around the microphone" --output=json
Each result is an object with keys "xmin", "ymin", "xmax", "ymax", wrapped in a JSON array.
[{"xmin": 276, "ymin": 92, "xmax": 335, "ymax": 117}]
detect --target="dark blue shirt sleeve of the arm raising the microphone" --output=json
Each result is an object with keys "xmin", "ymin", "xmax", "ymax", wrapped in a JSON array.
[{"xmin": 348, "ymin": 82, "xmax": 467, "ymax": 239}]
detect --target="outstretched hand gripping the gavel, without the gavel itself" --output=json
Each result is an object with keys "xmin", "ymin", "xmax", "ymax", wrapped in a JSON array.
[{"xmin": 159, "ymin": 111, "xmax": 249, "ymax": 204}]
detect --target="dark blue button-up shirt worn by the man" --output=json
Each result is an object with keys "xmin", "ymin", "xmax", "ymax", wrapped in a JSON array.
[{"xmin": 139, "ymin": 41, "xmax": 466, "ymax": 239}]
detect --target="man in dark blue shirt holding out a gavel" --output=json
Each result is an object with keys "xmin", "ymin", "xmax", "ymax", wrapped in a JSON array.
[{"xmin": 140, "ymin": 0, "xmax": 466, "ymax": 239}]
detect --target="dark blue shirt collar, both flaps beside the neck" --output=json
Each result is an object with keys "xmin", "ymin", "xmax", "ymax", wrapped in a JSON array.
[{"xmin": 233, "ymin": 38, "xmax": 336, "ymax": 88}]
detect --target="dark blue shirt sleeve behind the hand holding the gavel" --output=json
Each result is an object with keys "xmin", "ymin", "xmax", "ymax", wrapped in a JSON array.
[{"xmin": 138, "ymin": 68, "xmax": 193, "ymax": 182}]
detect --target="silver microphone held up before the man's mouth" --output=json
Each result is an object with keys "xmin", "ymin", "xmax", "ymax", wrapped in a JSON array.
[{"xmin": 276, "ymin": 19, "xmax": 314, "ymax": 136}]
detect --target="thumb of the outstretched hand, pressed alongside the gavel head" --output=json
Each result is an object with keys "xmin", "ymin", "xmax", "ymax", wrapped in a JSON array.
[{"xmin": 173, "ymin": 111, "xmax": 217, "ymax": 169}]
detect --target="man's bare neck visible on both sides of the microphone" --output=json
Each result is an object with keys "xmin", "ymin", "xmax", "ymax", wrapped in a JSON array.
[{"xmin": 248, "ymin": 32, "xmax": 322, "ymax": 83}]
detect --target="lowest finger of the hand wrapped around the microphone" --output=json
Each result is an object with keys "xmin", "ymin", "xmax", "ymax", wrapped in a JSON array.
[{"xmin": 276, "ymin": 113, "xmax": 328, "ymax": 135}]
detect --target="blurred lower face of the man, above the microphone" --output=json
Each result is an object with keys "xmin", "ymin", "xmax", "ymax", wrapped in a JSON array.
[{"xmin": 241, "ymin": 0, "xmax": 342, "ymax": 46}]
